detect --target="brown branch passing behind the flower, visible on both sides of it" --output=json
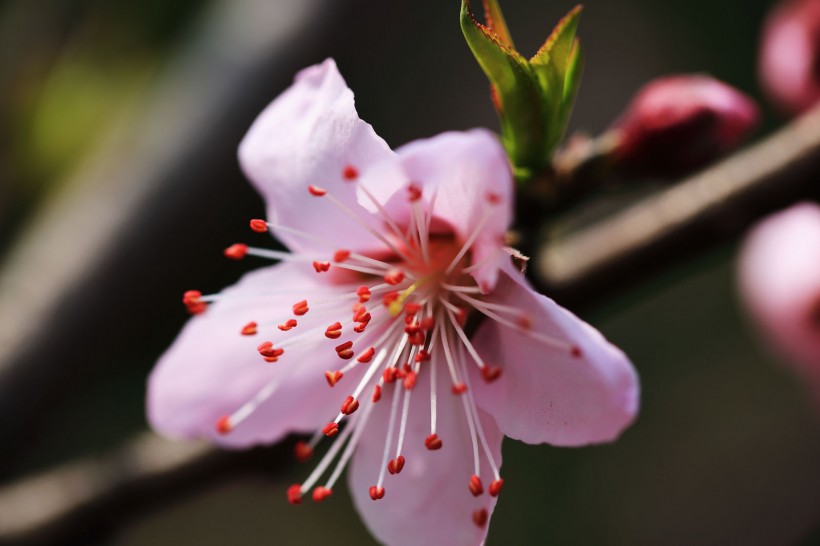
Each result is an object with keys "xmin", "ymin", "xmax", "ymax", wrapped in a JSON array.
[{"xmin": 0, "ymin": 88, "xmax": 820, "ymax": 543}]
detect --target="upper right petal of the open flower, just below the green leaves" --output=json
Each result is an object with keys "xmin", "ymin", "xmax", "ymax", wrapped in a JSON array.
[{"xmin": 359, "ymin": 129, "xmax": 514, "ymax": 290}]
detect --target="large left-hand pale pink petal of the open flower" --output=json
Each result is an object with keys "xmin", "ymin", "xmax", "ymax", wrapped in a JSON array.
[{"xmin": 147, "ymin": 264, "xmax": 366, "ymax": 447}]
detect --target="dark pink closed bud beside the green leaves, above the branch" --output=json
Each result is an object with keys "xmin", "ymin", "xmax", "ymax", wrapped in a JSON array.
[{"xmin": 613, "ymin": 74, "xmax": 758, "ymax": 175}]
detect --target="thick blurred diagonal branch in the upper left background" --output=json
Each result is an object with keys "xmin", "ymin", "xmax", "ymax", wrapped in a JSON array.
[{"xmin": 0, "ymin": 0, "xmax": 338, "ymax": 473}]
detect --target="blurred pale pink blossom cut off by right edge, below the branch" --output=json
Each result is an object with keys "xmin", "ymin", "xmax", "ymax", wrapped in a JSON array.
[{"xmin": 740, "ymin": 203, "xmax": 820, "ymax": 401}]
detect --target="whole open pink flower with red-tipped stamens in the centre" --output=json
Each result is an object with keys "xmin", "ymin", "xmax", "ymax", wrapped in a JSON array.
[{"xmin": 148, "ymin": 60, "xmax": 638, "ymax": 545}]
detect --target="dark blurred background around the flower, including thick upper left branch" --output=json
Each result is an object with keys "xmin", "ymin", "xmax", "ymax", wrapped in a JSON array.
[{"xmin": 0, "ymin": 0, "xmax": 820, "ymax": 546}]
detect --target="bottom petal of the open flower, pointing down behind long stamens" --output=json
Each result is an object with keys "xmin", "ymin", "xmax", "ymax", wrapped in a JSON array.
[{"xmin": 349, "ymin": 368, "xmax": 503, "ymax": 546}]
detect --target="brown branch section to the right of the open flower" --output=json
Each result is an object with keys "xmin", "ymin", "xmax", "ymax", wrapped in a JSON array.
[{"xmin": 535, "ymin": 104, "xmax": 820, "ymax": 301}]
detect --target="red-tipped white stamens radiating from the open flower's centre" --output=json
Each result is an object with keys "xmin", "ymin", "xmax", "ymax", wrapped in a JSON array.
[{"xmin": 183, "ymin": 166, "xmax": 580, "ymax": 527}]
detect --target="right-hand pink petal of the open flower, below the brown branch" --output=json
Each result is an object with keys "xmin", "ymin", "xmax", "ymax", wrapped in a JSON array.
[{"xmin": 473, "ymin": 260, "xmax": 640, "ymax": 446}]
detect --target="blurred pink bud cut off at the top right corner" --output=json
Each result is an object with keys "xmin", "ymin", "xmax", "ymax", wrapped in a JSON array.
[{"xmin": 759, "ymin": 0, "xmax": 820, "ymax": 114}]
